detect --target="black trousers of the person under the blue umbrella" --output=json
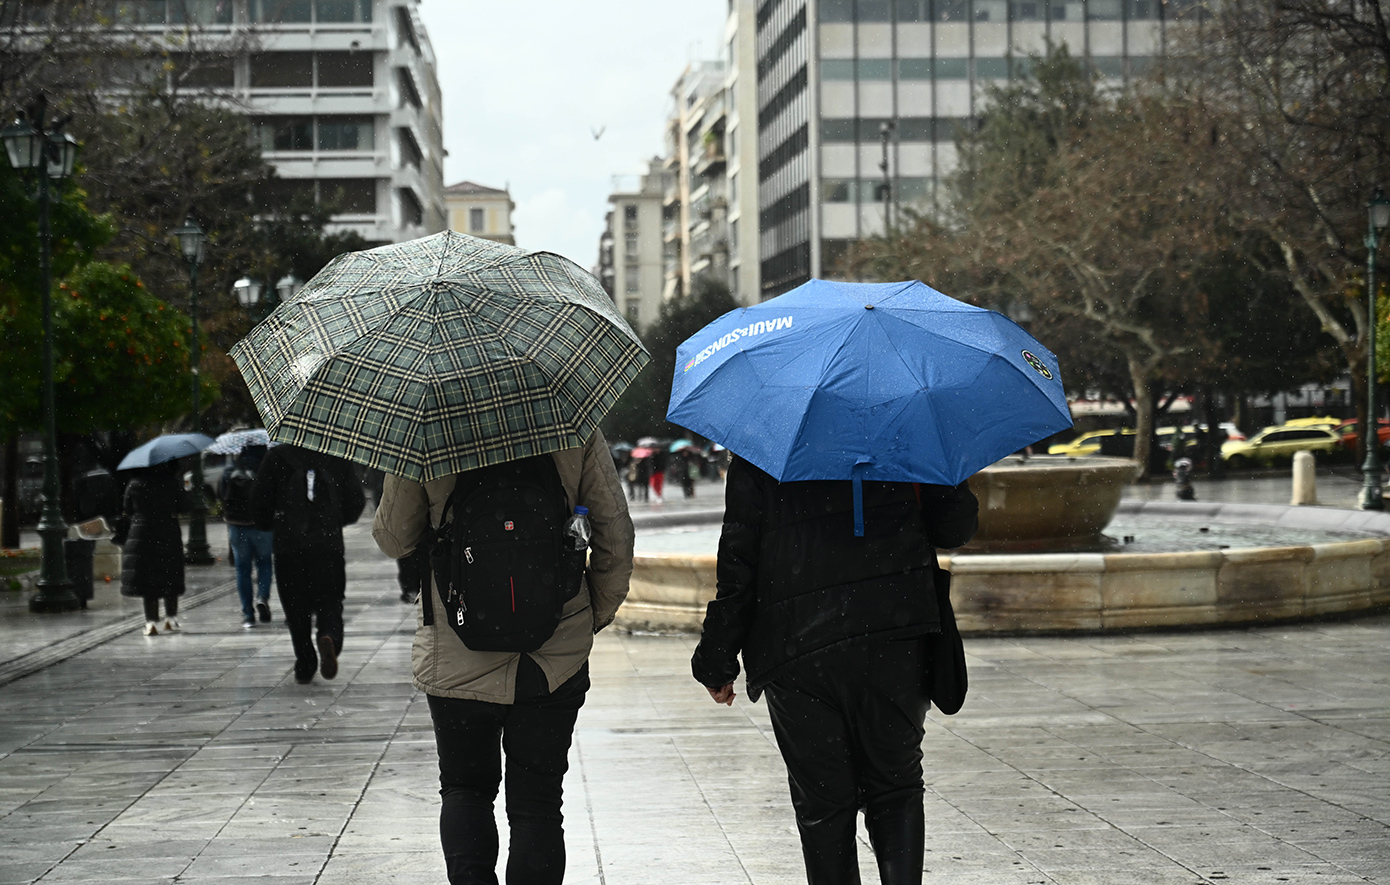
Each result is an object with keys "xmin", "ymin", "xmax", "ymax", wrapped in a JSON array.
[{"xmin": 766, "ymin": 639, "xmax": 930, "ymax": 885}]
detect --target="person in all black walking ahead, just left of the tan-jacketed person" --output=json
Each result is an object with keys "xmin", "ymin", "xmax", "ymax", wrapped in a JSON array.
[{"xmin": 252, "ymin": 446, "xmax": 367, "ymax": 685}]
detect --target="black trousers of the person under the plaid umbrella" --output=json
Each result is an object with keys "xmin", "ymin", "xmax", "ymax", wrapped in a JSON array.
[{"xmin": 428, "ymin": 654, "xmax": 589, "ymax": 885}]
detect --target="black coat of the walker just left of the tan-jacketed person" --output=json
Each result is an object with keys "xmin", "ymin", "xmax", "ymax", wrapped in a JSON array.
[{"xmin": 252, "ymin": 446, "xmax": 367, "ymax": 597}]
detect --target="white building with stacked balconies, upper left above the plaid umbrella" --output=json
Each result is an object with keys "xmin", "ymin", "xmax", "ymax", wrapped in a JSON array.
[{"xmin": 97, "ymin": 0, "xmax": 446, "ymax": 243}]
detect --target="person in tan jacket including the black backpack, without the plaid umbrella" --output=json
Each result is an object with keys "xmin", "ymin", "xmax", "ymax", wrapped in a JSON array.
[{"xmin": 373, "ymin": 431, "xmax": 634, "ymax": 885}]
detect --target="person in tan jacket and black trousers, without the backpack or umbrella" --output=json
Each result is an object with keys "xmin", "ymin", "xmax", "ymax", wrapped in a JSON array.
[{"xmin": 373, "ymin": 431, "xmax": 634, "ymax": 885}]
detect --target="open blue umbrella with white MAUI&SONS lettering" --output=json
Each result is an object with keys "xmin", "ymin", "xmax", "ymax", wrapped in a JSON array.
[{"xmin": 666, "ymin": 279, "xmax": 1072, "ymax": 534}]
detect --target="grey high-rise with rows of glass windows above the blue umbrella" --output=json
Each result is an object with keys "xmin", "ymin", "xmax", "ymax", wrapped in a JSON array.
[{"xmin": 750, "ymin": 0, "xmax": 1195, "ymax": 297}]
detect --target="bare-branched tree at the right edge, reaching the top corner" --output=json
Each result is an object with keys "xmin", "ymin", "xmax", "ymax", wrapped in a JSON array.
[{"xmin": 1168, "ymin": 0, "xmax": 1390, "ymax": 455}]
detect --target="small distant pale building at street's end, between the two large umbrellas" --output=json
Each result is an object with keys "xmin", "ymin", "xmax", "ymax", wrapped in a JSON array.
[{"xmin": 596, "ymin": 157, "xmax": 670, "ymax": 331}]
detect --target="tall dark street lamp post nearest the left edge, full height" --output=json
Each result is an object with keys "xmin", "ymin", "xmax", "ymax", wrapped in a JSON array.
[{"xmin": 0, "ymin": 96, "xmax": 82, "ymax": 611}]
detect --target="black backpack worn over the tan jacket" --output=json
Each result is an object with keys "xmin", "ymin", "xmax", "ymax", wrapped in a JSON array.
[{"xmin": 421, "ymin": 454, "xmax": 585, "ymax": 652}]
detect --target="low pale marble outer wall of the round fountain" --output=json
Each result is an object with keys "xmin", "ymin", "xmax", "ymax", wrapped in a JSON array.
[{"xmin": 619, "ymin": 502, "xmax": 1390, "ymax": 634}]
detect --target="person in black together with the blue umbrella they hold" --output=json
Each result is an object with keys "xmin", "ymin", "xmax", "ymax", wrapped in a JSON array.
[{"xmin": 667, "ymin": 281, "xmax": 1070, "ymax": 885}]
